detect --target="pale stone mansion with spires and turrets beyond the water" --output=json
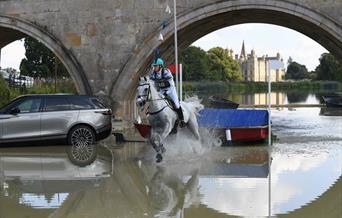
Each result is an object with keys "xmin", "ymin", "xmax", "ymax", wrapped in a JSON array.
[{"xmin": 230, "ymin": 42, "xmax": 285, "ymax": 82}]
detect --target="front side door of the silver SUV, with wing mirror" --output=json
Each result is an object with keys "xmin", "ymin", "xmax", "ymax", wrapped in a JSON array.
[{"xmin": 0, "ymin": 97, "xmax": 42, "ymax": 142}]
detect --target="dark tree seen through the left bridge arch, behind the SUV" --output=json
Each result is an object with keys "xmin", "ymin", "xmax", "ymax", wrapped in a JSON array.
[{"xmin": 20, "ymin": 37, "xmax": 69, "ymax": 78}]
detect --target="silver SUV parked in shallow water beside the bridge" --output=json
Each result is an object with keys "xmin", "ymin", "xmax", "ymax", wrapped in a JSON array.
[{"xmin": 0, "ymin": 94, "xmax": 112, "ymax": 147}]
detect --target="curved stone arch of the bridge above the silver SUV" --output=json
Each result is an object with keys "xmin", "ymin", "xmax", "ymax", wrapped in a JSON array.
[{"xmin": 0, "ymin": 15, "xmax": 92, "ymax": 95}]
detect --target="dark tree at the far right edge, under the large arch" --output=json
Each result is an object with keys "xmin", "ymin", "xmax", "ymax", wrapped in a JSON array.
[{"xmin": 315, "ymin": 53, "xmax": 342, "ymax": 82}]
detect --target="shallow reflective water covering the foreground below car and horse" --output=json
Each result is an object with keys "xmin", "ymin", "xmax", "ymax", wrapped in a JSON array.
[{"xmin": 0, "ymin": 108, "xmax": 342, "ymax": 218}]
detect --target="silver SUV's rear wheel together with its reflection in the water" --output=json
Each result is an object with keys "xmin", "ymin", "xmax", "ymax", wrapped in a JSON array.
[{"xmin": 67, "ymin": 125, "xmax": 97, "ymax": 167}]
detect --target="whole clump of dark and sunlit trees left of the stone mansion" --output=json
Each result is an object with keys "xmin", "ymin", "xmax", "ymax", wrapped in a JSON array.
[{"xmin": 180, "ymin": 46, "xmax": 242, "ymax": 81}]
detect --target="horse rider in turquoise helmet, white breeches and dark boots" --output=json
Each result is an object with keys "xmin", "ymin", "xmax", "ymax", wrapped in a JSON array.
[{"xmin": 149, "ymin": 58, "xmax": 185, "ymax": 127}]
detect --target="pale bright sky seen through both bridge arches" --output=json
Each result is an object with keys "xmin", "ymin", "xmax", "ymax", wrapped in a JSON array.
[{"xmin": 0, "ymin": 24, "xmax": 327, "ymax": 70}]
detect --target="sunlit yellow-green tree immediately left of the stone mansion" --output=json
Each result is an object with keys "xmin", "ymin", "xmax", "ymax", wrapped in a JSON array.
[{"xmin": 208, "ymin": 47, "xmax": 242, "ymax": 81}]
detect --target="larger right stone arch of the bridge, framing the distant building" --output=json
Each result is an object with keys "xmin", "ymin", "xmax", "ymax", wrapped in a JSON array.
[{"xmin": 111, "ymin": 0, "xmax": 342, "ymax": 100}]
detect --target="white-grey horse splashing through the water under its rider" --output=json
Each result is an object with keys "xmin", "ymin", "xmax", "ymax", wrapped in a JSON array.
[{"xmin": 136, "ymin": 77, "xmax": 203, "ymax": 163}]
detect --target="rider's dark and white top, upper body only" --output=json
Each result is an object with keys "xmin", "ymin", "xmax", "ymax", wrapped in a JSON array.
[{"xmin": 149, "ymin": 68, "xmax": 175, "ymax": 90}]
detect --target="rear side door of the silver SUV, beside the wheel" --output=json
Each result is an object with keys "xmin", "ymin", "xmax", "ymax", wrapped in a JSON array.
[{"xmin": 41, "ymin": 96, "xmax": 79, "ymax": 139}]
